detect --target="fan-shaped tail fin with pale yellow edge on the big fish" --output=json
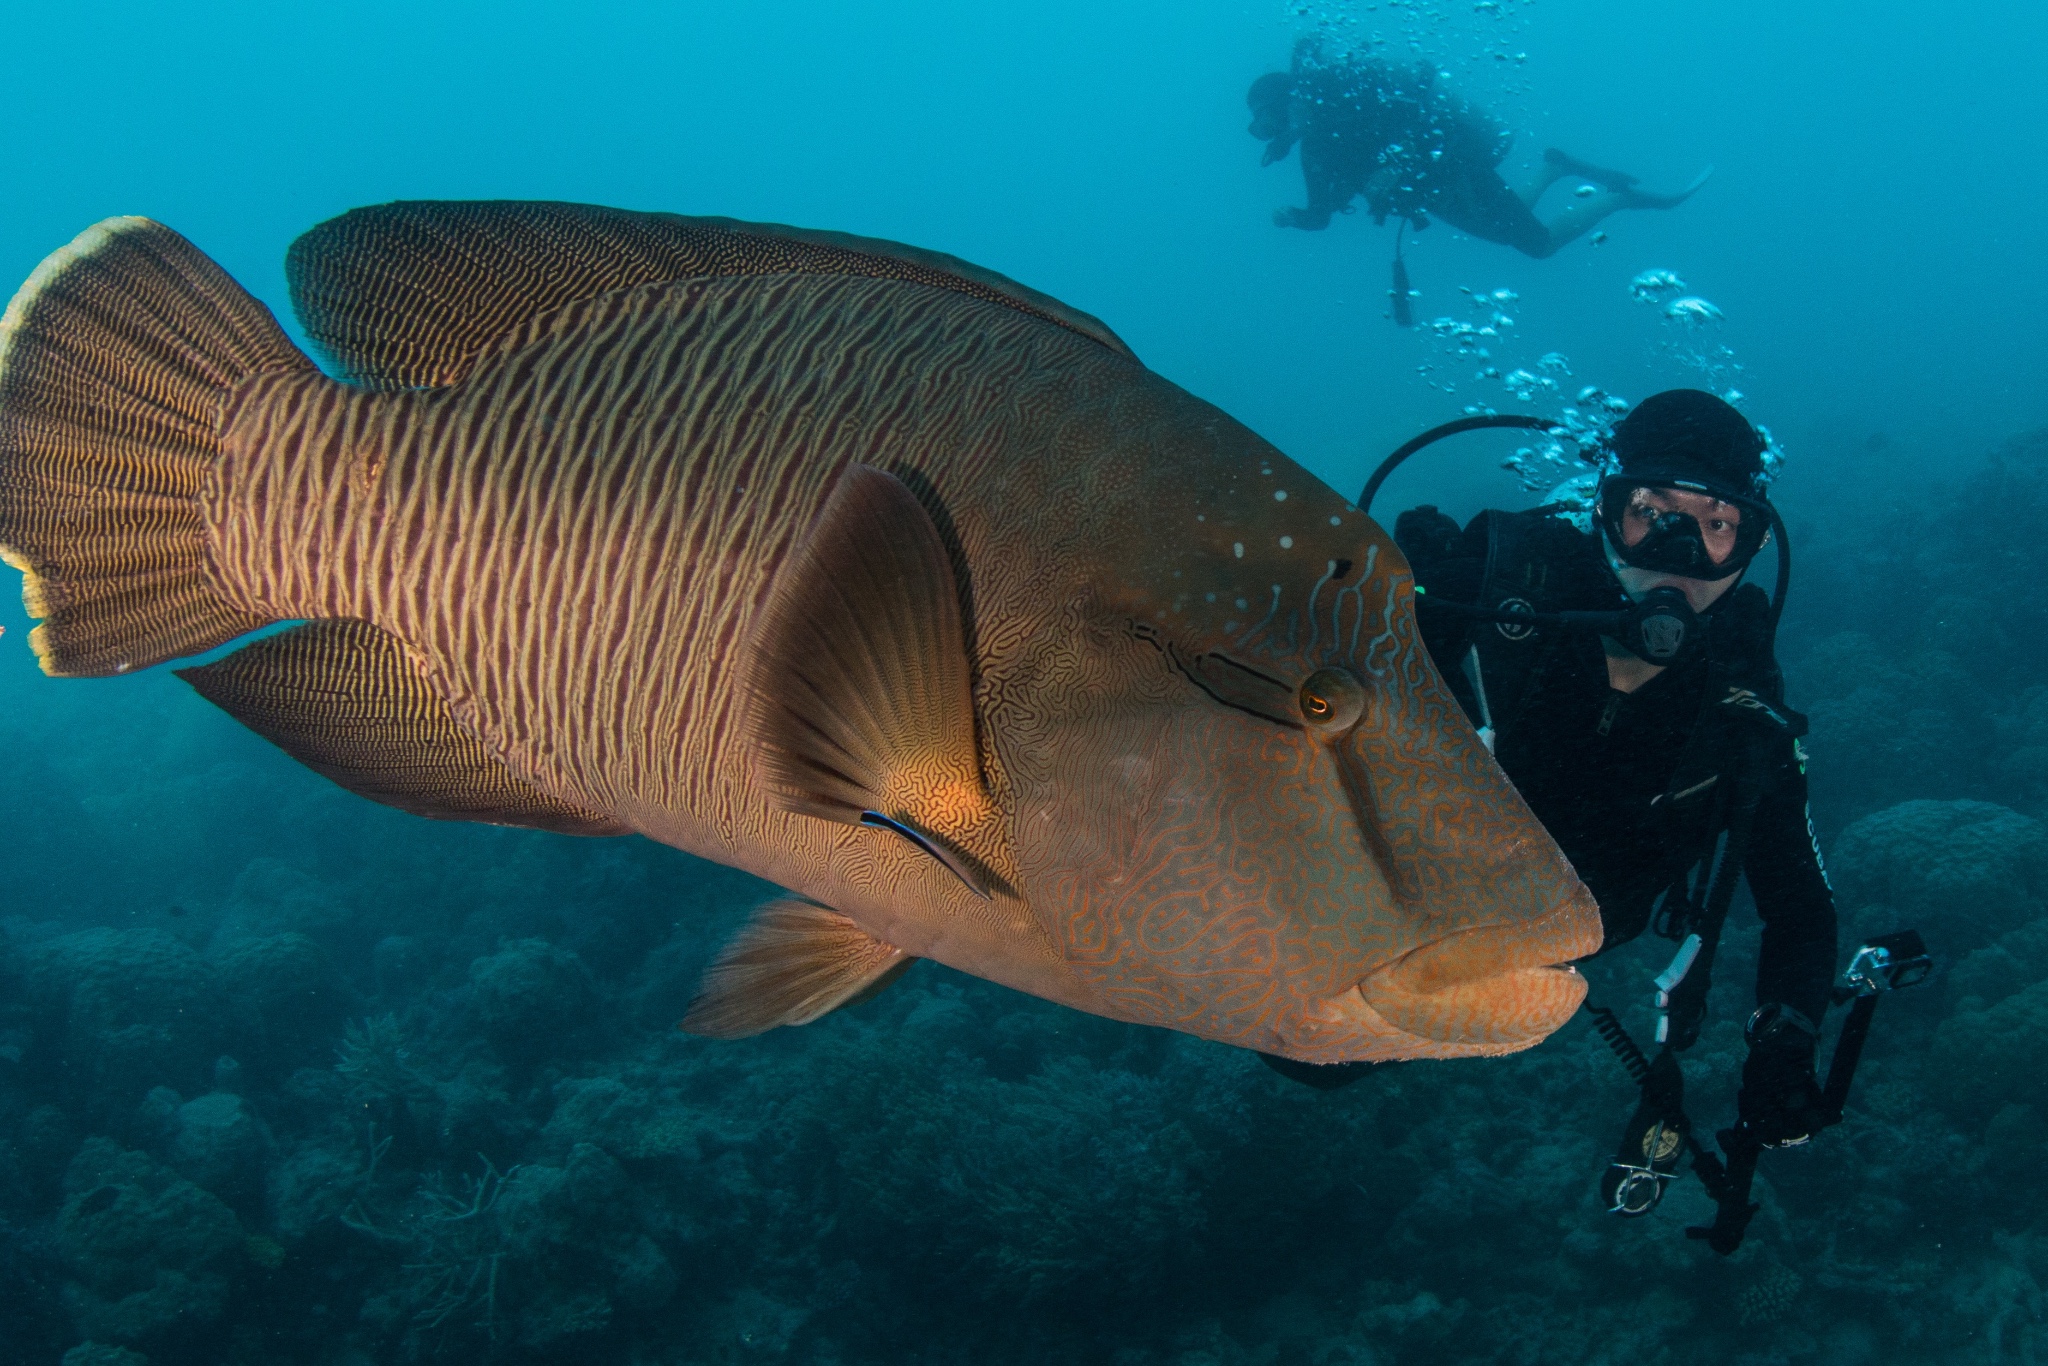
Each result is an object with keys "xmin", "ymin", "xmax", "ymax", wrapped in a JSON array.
[{"xmin": 0, "ymin": 217, "xmax": 313, "ymax": 678}]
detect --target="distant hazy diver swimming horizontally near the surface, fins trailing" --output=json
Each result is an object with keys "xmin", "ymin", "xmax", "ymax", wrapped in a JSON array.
[{"xmin": 1245, "ymin": 37, "xmax": 1712, "ymax": 259}]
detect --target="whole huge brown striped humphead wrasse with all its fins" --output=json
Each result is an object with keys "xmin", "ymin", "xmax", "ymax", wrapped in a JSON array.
[{"xmin": 0, "ymin": 203, "xmax": 1599, "ymax": 1063}]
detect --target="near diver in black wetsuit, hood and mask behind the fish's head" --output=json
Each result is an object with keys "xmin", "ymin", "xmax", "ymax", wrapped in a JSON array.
[{"xmin": 1266, "ymin": 389, "xmax": 1835, "ymax": 1236}]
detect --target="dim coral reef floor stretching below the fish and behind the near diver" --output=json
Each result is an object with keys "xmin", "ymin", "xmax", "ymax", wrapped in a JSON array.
[{"xmin": 0, "ymin": 430, "xmax": 2048, "ymax": 1366}]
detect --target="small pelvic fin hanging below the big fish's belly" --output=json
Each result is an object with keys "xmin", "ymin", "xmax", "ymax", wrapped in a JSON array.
[{"xmin": 682, "ymin": 897, "xmax": 918, "ymax": 1038}]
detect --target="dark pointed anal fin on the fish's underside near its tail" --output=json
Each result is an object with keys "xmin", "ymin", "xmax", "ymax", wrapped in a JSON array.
[{"xmin": 178, "ymin": 621, "xmax": 631, "ymax": 836}]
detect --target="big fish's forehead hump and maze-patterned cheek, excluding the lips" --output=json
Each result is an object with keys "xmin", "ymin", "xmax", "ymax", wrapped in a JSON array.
[{"xmin": 958, "ymin": 417, "xmax": 1581, "ymax": 1040}]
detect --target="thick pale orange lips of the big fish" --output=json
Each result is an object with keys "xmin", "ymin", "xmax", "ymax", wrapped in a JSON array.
[{"xmin": 1343, "ymin": 891, "xmax": 1602, "ymax": 1057}]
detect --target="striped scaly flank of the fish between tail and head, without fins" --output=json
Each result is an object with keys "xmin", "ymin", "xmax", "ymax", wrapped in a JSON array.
[{"xmin": 207, "ymin": 276, "xmax": 1236, "ymax": 995}]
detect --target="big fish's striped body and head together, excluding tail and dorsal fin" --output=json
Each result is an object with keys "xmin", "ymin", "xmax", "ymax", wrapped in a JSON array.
[{"xmin": 0, "ymin": 205, "xmax": 1597, "ymax": 1063}]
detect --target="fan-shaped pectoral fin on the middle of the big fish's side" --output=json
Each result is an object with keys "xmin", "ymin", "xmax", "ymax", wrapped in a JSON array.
[{"xmin": 748, "ymin": 465, "xmax": 993, "ymax": 897}]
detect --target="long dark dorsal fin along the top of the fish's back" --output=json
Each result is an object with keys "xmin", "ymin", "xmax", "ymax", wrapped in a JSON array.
[{"xmin": 285, "ymin": 201, "xmax": 1130, "ymax": 389}]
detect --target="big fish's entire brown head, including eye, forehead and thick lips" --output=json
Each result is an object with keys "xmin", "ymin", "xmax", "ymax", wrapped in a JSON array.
[{"xmin": 995, "ymin": 457, "xmax": 1602, "ymax": 1063}]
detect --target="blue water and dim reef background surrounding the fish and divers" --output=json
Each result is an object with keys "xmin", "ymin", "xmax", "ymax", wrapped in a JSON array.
[{"xmin": 0, "ymin": 0, "xmax": 2048, "ymax": 1366}]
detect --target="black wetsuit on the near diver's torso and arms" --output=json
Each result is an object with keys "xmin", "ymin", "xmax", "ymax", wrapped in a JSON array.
[{"xmin": 1403, "ymin": 512, "xmax": 1835, "ymax": 1020}]
